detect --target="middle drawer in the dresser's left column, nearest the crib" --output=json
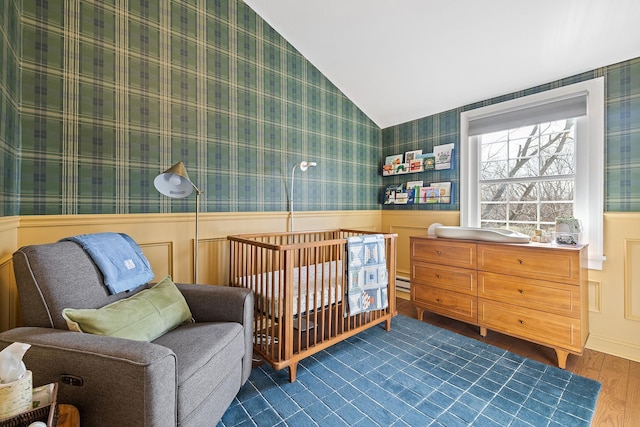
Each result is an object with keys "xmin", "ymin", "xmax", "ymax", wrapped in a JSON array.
[{"xmin": 411, "ymin": 262, "xmax": 478, "ymax": 296}]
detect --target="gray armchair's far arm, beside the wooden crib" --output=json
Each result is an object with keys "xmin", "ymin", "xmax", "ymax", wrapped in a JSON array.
[{"xmin": 176, "ymin": 284, "xmax": 254, "ymax": 384}]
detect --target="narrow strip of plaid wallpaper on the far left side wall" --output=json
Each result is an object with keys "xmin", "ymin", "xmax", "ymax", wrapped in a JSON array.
[{"xmin": 0, "ymin": 0, "xmax": 20, "ymax": 216}]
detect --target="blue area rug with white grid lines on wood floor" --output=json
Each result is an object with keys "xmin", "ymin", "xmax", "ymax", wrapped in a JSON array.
[{"xmin": 218, "ymin": 316, "xmax": 601, "ymax": 427}]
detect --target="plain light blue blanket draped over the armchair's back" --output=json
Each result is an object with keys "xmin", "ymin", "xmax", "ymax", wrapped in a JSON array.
[{"xmin": 62, "ymin": 233, "xmax": 153, "ymax": 294}]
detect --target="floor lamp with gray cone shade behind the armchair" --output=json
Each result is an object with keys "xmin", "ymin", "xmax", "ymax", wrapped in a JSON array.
[{"xmin": 153, "ymin": 162, "xmax": 202, "ymax": 283}]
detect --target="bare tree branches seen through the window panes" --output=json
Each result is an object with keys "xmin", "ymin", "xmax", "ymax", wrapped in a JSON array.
[{"xmin": 478, "ymin": 119, "xmax": 576, "ymax": 235}]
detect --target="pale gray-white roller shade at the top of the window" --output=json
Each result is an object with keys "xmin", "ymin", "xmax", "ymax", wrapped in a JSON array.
[{"xmin": 468, "ymin": 92, "xmax": 587, "ymax": 136}]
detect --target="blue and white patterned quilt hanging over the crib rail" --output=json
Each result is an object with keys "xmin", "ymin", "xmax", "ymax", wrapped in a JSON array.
[{"xmin": 347, "ymin": 234, "xmax": 389, "ymax": 316}]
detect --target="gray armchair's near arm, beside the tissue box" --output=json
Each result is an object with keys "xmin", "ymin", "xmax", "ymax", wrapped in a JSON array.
[{"xmin": 0, "ymin": 327, "xmax": 177, "ymax": 426}]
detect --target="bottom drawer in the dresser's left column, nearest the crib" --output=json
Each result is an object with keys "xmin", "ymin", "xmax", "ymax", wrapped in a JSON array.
[{"xmin": 411, "ymin": 283, "xmax": 478, "ymax": 324}]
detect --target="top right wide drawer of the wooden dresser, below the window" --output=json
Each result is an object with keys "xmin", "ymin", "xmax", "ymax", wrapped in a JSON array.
[{"xmin": 478, "ymin": 244, "xmax": 580, "ymax": 284}]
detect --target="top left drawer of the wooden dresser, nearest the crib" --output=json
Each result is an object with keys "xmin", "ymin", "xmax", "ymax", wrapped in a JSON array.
[{"xmin": 411, "ymin": 237, "xmax": 476, "ymax": 269}]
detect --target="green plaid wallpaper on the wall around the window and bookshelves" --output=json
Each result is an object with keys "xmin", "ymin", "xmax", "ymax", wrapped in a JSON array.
[{"xmin": 382, "ymin": 58, "xmax": 640, "ymax": 212}]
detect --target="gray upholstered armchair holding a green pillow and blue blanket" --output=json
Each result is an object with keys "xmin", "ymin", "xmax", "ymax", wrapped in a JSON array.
[{"xmin": 0, "ymin": 241, "xmax": 253, "ymax": 427}]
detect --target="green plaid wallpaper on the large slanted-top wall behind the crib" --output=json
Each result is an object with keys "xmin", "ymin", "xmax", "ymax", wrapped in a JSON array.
[{"xmin": 15, "ymin": 0, "xmax": 381, "ymax": 215}]
